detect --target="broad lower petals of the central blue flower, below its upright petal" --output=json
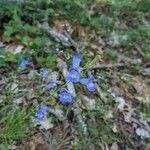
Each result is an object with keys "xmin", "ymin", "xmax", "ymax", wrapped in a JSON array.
[{"xmin": 66, "ymin": 68, "xmax": 80, "ymax": 83}]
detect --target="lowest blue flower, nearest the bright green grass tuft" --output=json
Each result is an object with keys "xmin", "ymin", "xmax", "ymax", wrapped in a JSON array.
[{"xmin": 36, "ymin": 105, "xmax": 49, "ymax": 122}]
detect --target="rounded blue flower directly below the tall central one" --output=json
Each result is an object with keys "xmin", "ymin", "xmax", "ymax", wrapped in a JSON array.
[{"xmin": 59, "ymin": 88, "xmax": 72, "ymax": 103}]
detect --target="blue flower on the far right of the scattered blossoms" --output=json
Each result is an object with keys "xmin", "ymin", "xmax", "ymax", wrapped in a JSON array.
[{"xmin": 80, "ymin": 76, "xmax": 96, "ymax": 92}]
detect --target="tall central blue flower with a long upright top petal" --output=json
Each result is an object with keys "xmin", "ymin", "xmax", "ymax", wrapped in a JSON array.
[{"xmin": 66, "ymin": 55, "xmax": 81, "ymax": 83}]
